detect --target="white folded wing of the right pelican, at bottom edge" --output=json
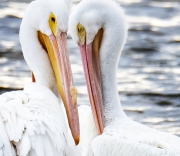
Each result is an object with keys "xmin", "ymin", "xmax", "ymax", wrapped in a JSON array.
[{"xmin": 92, "ymin": 135, "xmax": 180, "ymax": 156}]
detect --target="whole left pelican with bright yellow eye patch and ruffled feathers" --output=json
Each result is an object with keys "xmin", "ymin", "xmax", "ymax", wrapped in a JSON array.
[{"xmin": 0, "ymin": 0, "xmax": 80, "ymax": 156}]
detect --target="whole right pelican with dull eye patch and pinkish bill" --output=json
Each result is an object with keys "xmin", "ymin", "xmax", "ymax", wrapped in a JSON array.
[{"xmin": 69, "ymin": 0, "xmax": 180, "ymax": 156}]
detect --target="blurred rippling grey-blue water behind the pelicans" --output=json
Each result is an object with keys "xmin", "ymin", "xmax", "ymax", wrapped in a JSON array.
[{"xmin": 0, "ymin": 0, "xmax": 180, "ymax": 136}]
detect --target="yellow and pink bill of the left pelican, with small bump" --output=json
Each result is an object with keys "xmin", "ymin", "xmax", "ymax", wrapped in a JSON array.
[{"xmin": 38, "ymin": 31, "xmax": 80, "ymax": 144}]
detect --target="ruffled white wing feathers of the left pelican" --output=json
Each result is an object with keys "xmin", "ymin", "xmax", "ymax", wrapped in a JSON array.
[{"xmin": 0, "ymin": 83, "xmax": 68, "ymax": 156}]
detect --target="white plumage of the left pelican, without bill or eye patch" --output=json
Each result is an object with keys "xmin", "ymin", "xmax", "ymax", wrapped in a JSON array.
[{"xmin": 0, "ymin": 0, "xmax": 80, "ymax": 156}]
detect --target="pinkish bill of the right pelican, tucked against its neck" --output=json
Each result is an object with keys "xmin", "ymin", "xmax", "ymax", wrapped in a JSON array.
[{"xmin": 79, "ymin": 30, "xmax": 104, "ymax": 134}]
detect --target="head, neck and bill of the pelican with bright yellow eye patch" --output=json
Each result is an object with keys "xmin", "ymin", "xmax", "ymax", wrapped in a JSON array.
[{"xmin": 20, "ymin": 0, "xmax": 79, "ymax": 144}]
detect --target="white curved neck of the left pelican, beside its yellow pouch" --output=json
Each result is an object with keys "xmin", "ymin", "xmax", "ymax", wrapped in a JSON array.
[{"xmin": 19, "ymin": 18, "xmax": 59, "ymax": 97}]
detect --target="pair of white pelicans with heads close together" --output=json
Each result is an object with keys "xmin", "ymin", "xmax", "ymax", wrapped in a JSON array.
[{"xmin": 0, "ymin": 0, "xmax": 180, "ymax": 156}]
